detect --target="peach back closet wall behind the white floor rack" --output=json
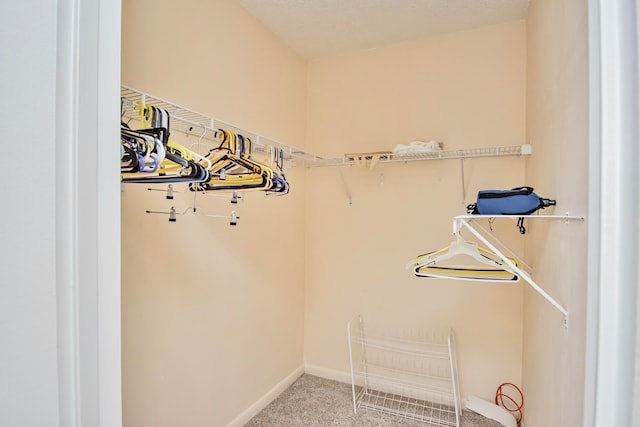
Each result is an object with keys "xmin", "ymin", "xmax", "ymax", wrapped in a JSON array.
[{"xmin": 305, "ymin": 21, "xmax": 526, "ymax": 399}]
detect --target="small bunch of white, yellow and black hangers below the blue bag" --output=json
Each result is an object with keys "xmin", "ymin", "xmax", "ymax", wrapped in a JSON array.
[{"xmin": 407, "ymin": 235, "xmax": 520, "ymax": 283}]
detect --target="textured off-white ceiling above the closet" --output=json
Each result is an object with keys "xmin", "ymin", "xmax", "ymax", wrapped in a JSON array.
[{"xmin": 238, "ymin": 0, "xmax": 529, "ymax": 59}]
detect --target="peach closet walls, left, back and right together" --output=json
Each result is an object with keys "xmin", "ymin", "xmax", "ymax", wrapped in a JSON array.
[{"xmin": 121, "ymin": 0, "xmax": 588, "ymax": 426}]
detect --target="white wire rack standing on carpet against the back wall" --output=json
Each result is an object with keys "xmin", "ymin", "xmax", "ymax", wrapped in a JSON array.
[{"xmin": 347, "ymin": 316, "xmax": 462, "ymax": 427}]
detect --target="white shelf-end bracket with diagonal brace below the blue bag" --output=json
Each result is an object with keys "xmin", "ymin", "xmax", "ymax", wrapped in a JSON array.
[{"xmin": 453, "ymin": 213, "xmax": 584, "ymax": 328}]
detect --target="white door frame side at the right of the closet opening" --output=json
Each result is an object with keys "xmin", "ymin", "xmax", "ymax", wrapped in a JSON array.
[{"xmin": 583, "ymin": 0, "xmax": 640, "ymax": 427}]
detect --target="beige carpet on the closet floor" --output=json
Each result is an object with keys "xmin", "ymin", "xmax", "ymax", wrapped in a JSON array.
[{"xmin": 245, "ymin": 374, "xmax": 502, "ymax": 427}]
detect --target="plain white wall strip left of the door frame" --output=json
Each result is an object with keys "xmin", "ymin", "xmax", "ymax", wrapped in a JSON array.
[{"xmin": 0, "ymin": 1, "xmax": 58, "ymax": 426}]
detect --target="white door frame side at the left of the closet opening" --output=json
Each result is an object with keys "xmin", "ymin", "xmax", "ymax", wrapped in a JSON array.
[{"xmin": 55, "ymin": 0, "xmax": 122, "ymax": 427}]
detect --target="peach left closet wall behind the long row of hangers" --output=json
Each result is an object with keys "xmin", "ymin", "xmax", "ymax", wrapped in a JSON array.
[{"xmin": 122, "ymin": 0, "xmax": 306, "ymax": 427}]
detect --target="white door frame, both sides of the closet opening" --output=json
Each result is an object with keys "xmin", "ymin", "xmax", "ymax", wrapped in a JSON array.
[{"xmin": 56, "ymin": 0, "xmax": 640, "ymax": 427}]
